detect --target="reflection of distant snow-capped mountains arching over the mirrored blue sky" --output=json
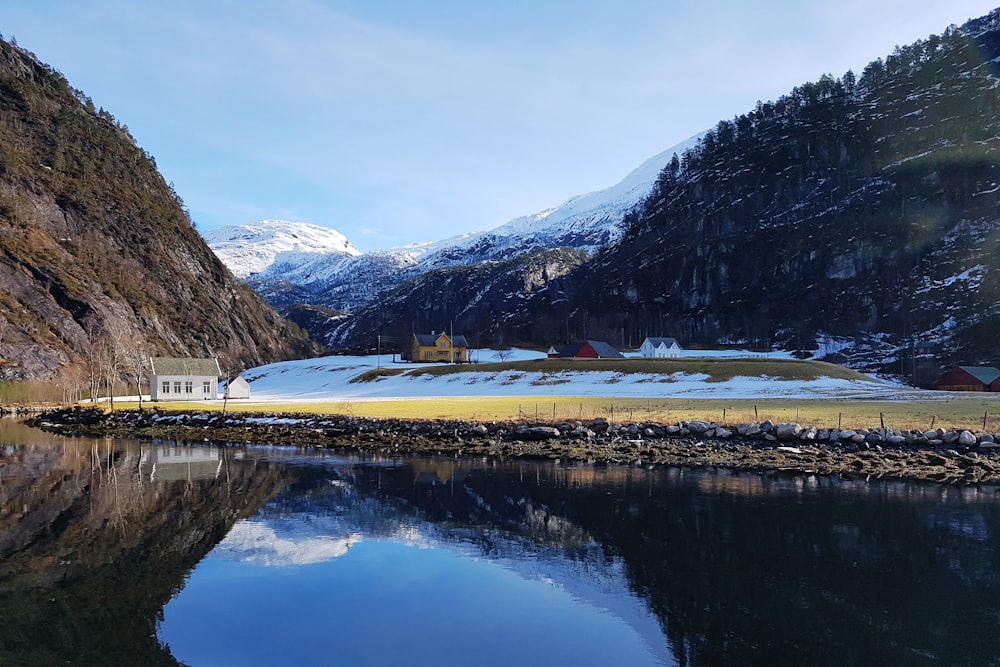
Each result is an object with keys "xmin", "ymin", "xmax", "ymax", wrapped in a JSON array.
[{"xmin": 211, "ymin": 458, "xmax": 664, "ymax": 655}]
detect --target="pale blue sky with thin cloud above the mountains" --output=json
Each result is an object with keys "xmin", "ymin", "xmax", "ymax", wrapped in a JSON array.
[{"xmin": 0, "ymin": 0, "xmax": 997, "ymax": 251}]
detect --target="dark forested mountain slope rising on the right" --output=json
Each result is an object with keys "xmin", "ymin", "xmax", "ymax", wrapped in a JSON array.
[{"xmin": 398, "ymin": 7, "xmax": 1000, "ymax": 381}]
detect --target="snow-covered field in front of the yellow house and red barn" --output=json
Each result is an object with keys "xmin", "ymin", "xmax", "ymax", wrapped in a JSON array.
[{"xmin": 243, "ymin": 350, "xmax": 913, "ymax": 403}]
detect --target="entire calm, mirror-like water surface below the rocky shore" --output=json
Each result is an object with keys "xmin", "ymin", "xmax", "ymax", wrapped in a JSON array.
[{"xmin": 0, "ymin": 421, "xmax": 1000, "ymax": 665}]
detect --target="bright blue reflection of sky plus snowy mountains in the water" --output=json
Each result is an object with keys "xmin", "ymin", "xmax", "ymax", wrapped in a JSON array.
[{"xmin": 158, "ymin": 478, "xmax": 672, "ymax": 665}]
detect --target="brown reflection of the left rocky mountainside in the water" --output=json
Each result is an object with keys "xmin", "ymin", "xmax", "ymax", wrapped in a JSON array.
[{"xmin": 0, "ymin": 420, "xmax": 285, "ymax": 665}]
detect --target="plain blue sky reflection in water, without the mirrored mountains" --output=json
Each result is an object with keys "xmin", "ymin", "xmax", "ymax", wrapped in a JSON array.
[{"xmin": 159, "ymin": 539, "xmax": 672, "ymax": 665}]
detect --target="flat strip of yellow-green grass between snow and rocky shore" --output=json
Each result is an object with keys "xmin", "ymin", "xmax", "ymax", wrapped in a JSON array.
[{"xmin": 123, "ymin": 392, "xmax": 1000, "ymax": 432}]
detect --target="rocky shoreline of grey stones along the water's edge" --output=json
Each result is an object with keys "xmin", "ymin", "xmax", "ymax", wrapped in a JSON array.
[{"xmin": 26, "ymin": 408, "xmax": 1000, "ymax": 485}]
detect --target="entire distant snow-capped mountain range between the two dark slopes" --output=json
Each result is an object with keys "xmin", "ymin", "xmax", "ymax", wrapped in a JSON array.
[{"xmin": 203, "ymin": 135, "xmax": 700, "ymax": 311}]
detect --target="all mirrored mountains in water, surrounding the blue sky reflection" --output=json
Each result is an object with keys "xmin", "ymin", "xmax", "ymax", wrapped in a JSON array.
[{"xmin": 0, "ymin": 421, "xmax": 1000, "ymax": 665}]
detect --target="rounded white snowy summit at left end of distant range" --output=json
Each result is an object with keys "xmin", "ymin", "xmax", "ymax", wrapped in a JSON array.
[{"xmin": 202, "ymin": 220, "xmax": 361, "ymax": 278}]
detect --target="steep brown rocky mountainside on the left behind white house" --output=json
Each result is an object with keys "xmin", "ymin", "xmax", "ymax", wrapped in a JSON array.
[{"xmin": 0, "ymin": 41, "xmax": 314, "ymax": 379}]
